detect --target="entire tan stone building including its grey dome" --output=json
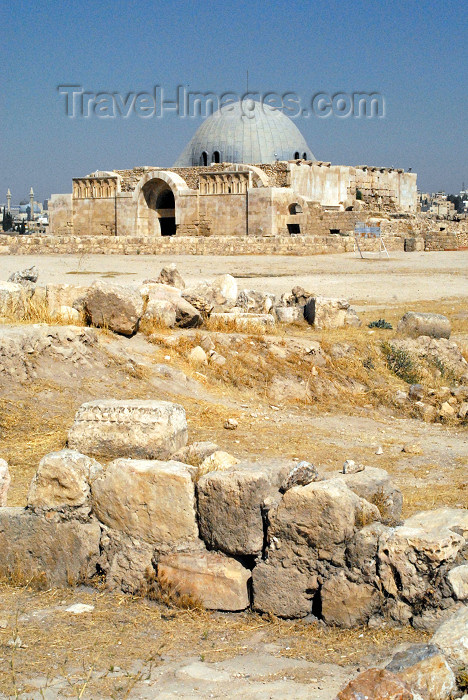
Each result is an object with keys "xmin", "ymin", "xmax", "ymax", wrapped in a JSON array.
[{"xmin": 49, "ymin": 102, "xmax": 418, "ymax": 237}]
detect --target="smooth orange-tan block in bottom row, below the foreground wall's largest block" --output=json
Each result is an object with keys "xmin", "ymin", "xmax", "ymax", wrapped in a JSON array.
[{"xmin": 158, "ymin": 552, "xmax": 251, "ymax": 611}]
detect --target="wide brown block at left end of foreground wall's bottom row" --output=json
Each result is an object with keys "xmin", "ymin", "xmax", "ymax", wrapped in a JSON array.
[{"xmin": 0, "ymin": 508, "xmax": 101, "ymax": 586}]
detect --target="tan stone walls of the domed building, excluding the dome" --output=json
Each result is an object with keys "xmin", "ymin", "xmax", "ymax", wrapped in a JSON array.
[{"xmin": 49, "ymin": 160, "xmax": 417, "ymax": 237}]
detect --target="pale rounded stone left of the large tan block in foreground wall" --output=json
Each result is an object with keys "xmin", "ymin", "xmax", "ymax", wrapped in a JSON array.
[{"xmin": 28, "ymin": 450, "xmax": 102, "ymax": 510}]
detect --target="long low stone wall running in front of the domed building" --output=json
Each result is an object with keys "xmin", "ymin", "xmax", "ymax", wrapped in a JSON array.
[{"xmin": 0, "ymin": 235, "xmax": 404, "ymax": 255}]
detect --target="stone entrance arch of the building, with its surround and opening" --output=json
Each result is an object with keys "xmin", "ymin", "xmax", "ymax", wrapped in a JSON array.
[{"xmin": 133, "ymin": 170, "xmax": 187, "ymax": 236}]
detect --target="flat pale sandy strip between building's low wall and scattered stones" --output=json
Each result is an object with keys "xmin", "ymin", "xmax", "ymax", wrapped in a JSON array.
[{"xmin": 0, "ymin": 251, "xmax": 468, "ymax": 307}]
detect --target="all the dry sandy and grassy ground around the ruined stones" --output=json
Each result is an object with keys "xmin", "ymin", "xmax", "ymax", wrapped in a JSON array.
[{"xmin": 0, "ymin": 251, "xmax": 468, "ymax": 700}]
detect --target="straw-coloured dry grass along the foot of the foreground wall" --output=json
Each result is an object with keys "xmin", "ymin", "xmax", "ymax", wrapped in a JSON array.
[{"xmin": 0, "ymin": 585, "xmax": 428, "ymax": 698}]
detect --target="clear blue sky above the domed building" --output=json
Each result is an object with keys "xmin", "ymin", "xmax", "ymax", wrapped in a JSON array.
[{"xmin": 0, "ymin": 0, "xmax": 468, "ymax": 203}]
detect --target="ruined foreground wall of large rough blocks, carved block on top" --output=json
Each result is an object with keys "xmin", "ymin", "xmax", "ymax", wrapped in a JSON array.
[{"xmin": 0, "ymin": 400, "xmax": 468, "ymax": 628}]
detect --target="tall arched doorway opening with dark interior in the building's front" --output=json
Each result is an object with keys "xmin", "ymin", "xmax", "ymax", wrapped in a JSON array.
[{"xmin": 138, "ymin": 178, "xmax": 176, "ymax": 236}]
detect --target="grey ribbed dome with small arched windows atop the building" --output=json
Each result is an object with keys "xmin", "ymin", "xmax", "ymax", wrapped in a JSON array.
[{"xmin": 174, "ymin": 100, "xmax": 315, "ymax": 168}]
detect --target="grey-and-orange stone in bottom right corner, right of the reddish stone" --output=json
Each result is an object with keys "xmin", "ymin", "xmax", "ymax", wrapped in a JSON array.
[{"xmin": 386, "ymin": 644, "xmax": 456, "ymax": 700}]
